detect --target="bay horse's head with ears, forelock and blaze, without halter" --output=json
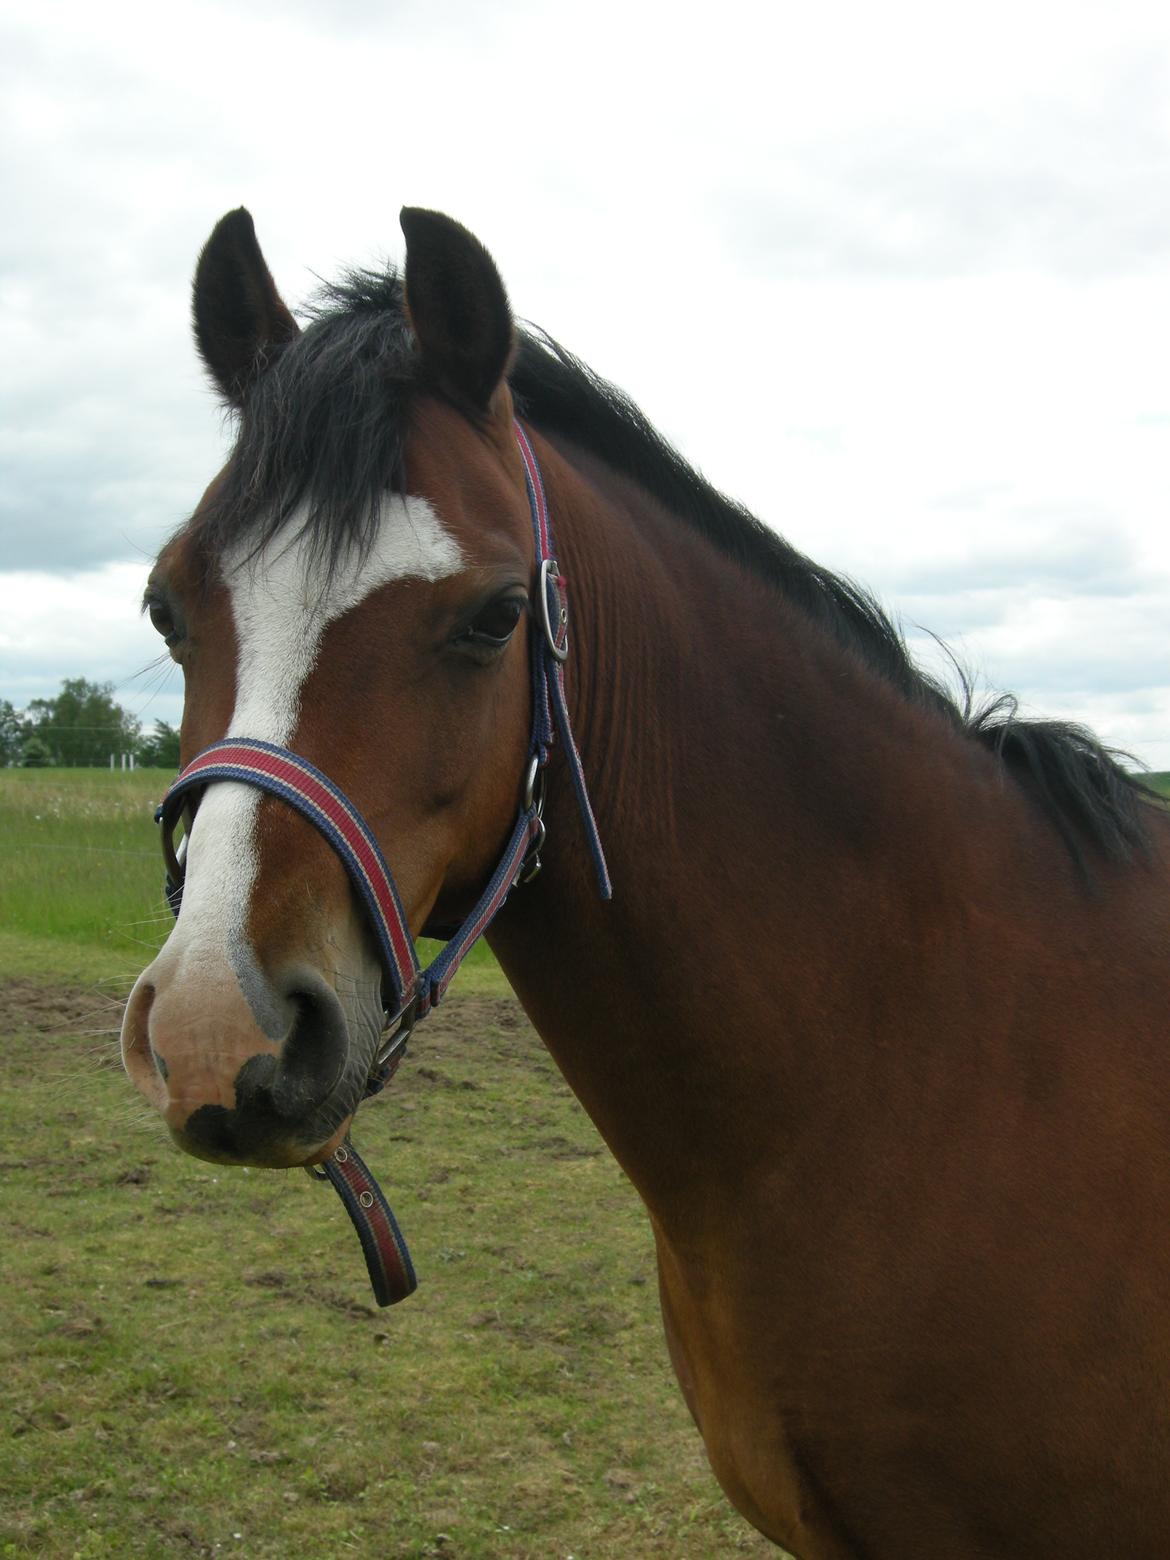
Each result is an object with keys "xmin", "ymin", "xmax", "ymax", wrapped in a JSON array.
[{"xmin": 122, "ymin": 209, "xmax": 535, "ymax": 1165}]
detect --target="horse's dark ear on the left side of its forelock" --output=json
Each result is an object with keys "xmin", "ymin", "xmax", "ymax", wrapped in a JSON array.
[{"xmin": 192, "ymin": 206, "xmax": 300, "ymax": 407}]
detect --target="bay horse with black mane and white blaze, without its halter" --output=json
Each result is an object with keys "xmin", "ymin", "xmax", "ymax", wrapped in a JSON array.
[{"xmin": 122, "ymin": 209, "xmax": 1170, "ymax": 1560}]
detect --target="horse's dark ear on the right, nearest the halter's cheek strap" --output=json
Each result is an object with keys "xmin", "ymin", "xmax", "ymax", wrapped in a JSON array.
[{"xmin": 399, "ymin": 206, "xmax": 513, "ymax": 410}]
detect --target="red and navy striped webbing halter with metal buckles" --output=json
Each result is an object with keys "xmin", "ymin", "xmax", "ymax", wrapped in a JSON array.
[{"xmin": 154, "ymin": 423, "xmax": 613, "ymax": 1306}]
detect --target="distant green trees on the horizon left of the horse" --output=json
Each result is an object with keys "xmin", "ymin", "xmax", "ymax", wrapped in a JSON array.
[{"xmin": 0, "ymin": 677, "xmax": 179, "ymax": 769}]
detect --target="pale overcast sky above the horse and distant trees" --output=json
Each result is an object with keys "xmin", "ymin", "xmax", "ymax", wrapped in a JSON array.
[{"xmin": 0, "ymin": 0, "xmax": 1170, "ymax": 769}]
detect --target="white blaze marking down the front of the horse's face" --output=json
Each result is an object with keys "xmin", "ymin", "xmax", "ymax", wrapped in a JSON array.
[{"xmin": 161, "ymin": 496, "xmax": 463, "ymax": 985}]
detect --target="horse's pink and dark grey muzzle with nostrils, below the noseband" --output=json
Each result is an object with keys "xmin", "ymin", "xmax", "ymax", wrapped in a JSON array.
[{"xmin": 122, "ymin": 952, "xmax": 381, "ymax": 1168}]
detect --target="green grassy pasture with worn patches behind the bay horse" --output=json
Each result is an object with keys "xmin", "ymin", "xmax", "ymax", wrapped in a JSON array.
[{"xmin": 0, "ymin": 771, "xmax": 777, "ymax": 1560}]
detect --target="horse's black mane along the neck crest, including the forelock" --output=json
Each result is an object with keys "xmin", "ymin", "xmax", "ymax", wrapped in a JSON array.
[{"xmin": 201, "ymin": 268, "xmax": 1151, "ymax": 863}]
